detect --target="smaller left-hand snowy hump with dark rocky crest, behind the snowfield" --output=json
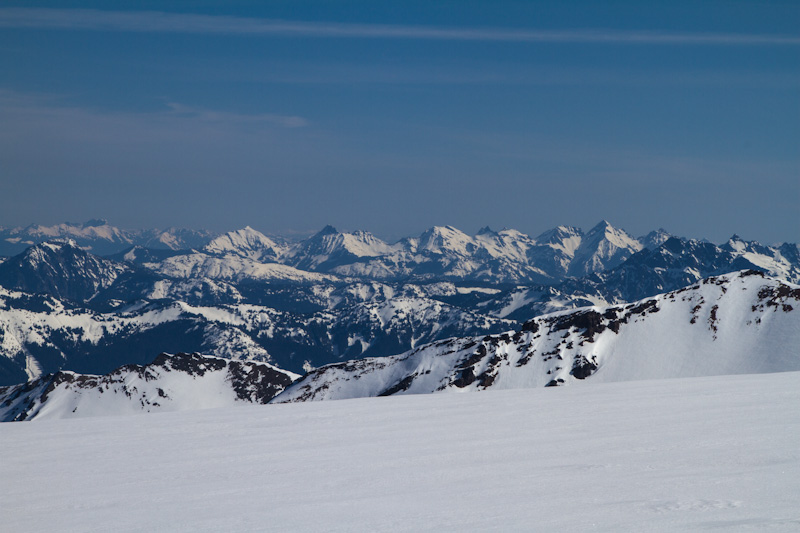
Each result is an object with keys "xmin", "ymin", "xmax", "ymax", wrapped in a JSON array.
[{"xmin": 0, "ymin": 353, "xmax": 300, "ymax": 422}]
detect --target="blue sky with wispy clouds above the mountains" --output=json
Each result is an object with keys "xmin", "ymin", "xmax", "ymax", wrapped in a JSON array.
[{"xmin": 0, "ymin": 0, "xmax": 800, "ymax": 243}]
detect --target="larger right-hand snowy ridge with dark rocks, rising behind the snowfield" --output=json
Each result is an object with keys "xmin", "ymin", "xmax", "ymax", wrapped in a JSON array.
[{"xmin": 273, "ymin": 270, "xmax": 800, "ymax": 402}]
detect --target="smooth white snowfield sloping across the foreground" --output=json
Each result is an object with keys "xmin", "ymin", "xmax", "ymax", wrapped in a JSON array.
[{"xmin": 0, "ymin": 372, "xmax": 800, "ymax": 531}]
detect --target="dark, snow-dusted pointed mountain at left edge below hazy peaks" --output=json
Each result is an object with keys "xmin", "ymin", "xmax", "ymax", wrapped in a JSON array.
[{"xmin": 0, "ymin": 239, "xmax": 131, "ymax": 302}]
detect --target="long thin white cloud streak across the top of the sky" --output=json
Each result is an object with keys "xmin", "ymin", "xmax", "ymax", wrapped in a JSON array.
[{"xmin": 0, "ymin": 8, "xmax": 800, "ymax": 46}]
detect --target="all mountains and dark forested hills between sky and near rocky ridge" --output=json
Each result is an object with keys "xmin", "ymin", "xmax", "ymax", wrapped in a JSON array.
[{"xmin": 0, "ymin": 217, "xmax": 800, "ymax": 400}]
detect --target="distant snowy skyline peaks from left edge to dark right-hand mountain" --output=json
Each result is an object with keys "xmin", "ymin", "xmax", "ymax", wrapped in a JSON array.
[{"xmin": 0, "ymin": 220, "xmax": 680, "ymax": 283}]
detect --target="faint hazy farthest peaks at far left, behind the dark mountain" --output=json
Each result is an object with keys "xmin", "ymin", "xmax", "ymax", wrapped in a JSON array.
[{"xmin": 0, "ymin": 219, "xmax": 213, "ymax": 256}]
